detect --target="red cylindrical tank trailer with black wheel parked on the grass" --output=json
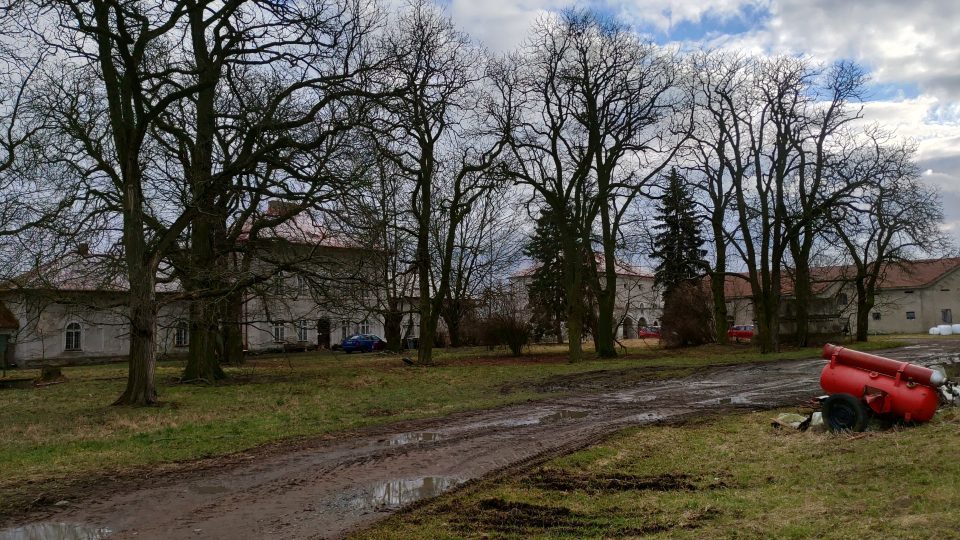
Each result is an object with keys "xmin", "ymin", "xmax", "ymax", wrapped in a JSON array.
[{"xmin": 820, "ymin": 344, "xmax": 946, "ymax": 431}]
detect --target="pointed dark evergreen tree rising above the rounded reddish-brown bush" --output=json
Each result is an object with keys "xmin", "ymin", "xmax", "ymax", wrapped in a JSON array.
[{"xmin": 651, "ymin": 169, "xmax": 710, "ymax": 297}]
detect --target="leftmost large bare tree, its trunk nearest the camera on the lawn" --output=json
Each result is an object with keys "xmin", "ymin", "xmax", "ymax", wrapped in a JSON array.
[{"xmin": 15, "ymin": 0, "xmax": 206, "ymax": 405}]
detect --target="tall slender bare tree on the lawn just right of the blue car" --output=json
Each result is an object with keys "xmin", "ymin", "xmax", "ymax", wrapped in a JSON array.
[{"xmin": 375, "ymin": 0, "xmax": 509, "ymax": 364}]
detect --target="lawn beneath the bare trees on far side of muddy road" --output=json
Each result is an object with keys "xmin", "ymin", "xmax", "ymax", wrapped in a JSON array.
[{"xmin": 0, "ymin": 342, "xmax": 892, "ymax": 515}]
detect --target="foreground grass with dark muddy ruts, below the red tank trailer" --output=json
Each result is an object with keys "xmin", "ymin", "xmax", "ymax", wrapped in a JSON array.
[{"xmin": 357, "ymin": 410, "xmax": 960, "ymax": 539}]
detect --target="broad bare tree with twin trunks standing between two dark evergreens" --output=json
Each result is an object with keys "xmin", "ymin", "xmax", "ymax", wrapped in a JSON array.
[{"xmin": 502, "ymin": 10, "xmax": 685, "ymax": 361}]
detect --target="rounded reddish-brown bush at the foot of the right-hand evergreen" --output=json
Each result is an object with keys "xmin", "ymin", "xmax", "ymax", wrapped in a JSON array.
[{"xmin": 661, "ymin": 282, "xmax": 713, "ymax": 348}]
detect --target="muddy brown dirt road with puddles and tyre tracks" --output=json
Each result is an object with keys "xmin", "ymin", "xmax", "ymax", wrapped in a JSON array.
[{"xmin": 7, "ymin": 341, "xmax": 960, "ymax": 540}]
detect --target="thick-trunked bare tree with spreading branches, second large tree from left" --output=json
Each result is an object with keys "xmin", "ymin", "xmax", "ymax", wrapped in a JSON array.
[{"xmin": 148, "ymin": 0, "xmax": 381, "ymax": 381}]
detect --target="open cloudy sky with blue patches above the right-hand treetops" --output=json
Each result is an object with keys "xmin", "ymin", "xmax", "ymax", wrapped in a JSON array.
[{"xmin": 437, "ymin": 0, "xmax": 960, "ymax": 245}]
